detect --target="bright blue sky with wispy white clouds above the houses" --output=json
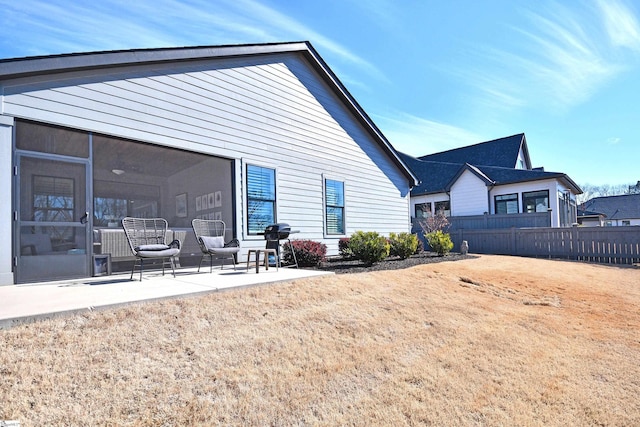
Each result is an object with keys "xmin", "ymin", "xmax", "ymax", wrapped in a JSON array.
[{"xmin": 0, "ymin": 0, "xmax": 640, "ymax": 185}]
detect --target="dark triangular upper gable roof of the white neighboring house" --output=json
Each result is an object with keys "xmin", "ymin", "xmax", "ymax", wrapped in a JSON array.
[{"xmin": 418, "ymin": 133, "xmax": 531, "ymax": 169}]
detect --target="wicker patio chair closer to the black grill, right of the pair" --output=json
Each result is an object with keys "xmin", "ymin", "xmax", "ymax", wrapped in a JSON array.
[{"xmin": 191, "ymin": 219, "xmax": 240, "ymax": 272}]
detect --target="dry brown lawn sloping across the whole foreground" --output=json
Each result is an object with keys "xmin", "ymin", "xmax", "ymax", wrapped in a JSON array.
[{"xmin": 0, "ymin": 256, "xmax": 640, "ymax": 426}]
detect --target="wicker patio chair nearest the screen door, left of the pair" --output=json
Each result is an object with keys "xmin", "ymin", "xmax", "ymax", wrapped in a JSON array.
[{"xmin": 122, "ymin": 217, "xmax": 180, "ymax": 281}]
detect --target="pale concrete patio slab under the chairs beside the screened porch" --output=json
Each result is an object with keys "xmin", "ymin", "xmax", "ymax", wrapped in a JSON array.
[{"xmin": 0, "ymin": 266, "xmax": 333, "ymax": 329}]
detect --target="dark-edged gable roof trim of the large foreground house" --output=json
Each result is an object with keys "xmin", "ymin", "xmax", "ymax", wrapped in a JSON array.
[{"xmin": 0, "ymin": 41, "xmax": 418, "ymax": 187}]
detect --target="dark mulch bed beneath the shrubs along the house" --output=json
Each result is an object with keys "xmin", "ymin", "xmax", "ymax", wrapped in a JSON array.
[{"xmin": 316, "ymin": 252, "xmax": 475, "ymax": 274}]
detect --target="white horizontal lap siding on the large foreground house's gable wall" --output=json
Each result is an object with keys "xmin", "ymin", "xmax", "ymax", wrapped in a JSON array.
[{"xmin": 2, "ymin": 53, "xmax": 409, "ymax": 270}]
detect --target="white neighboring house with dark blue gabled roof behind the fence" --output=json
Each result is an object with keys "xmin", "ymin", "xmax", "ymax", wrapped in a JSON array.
[{"xmin": 401, "ymin": 134, "xmax": 582, "ymax": 227}]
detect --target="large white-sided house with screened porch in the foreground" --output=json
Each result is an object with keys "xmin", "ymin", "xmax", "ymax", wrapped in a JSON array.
[{"xmin": 0, "ymin": 42, "xmax": 417, "ymax": 284}]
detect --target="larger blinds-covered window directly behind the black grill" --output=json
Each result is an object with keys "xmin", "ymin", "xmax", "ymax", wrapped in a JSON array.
[{"xmin": 247, "ymin": 165, "xmax": 276, "ymax": 234}]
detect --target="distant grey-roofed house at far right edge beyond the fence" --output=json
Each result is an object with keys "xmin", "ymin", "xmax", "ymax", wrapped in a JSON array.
[{"xmin": 578, "ymin": 194, "xmax": 640, "ymax": 227}]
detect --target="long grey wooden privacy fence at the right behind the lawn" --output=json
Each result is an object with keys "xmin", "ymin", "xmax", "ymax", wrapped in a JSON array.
[{"xmin": 449, "ymin": 226, "xmax": 640, "ymax": 264}]
